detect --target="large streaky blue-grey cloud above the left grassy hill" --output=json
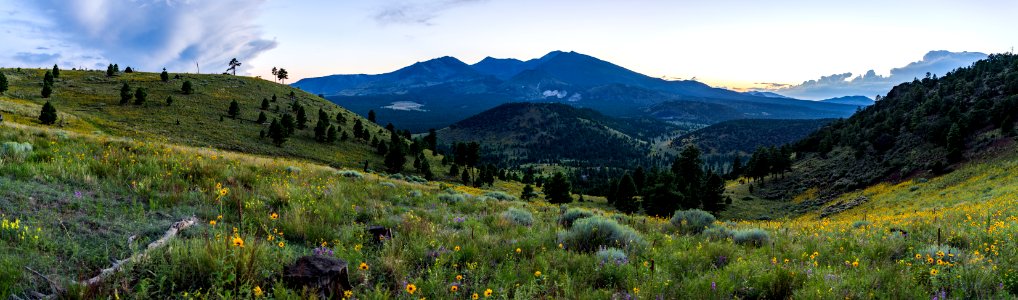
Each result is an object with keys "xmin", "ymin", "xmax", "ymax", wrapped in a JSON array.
[{"xmin": 4, "ymin": 0, "xmax": 277, "ymax": 73}]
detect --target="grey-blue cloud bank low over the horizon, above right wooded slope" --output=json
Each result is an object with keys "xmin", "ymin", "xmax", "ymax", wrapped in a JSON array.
[{"xmin": 767, "ymin": 51, "xmax": 986, "ymax": 100}]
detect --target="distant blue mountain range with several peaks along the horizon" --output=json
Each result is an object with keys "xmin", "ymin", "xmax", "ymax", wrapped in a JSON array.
[{"xmin": 292, "ymin": 51, "xmax": 858, "ymax": 132}]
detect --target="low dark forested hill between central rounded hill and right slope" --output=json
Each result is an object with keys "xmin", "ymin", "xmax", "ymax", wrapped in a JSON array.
[{"xmin": 672, "ymin": 119, "xmax": 834, "ymax": 158}]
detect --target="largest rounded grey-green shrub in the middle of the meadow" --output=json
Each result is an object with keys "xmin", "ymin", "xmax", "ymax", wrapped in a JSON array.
[{"xmin": 561, "ymin": 217, "xmax": 643, "ymax": 252}]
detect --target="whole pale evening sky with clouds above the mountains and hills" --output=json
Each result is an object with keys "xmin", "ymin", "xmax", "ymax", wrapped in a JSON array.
[{"xmin": 0, "ymin": 0, "xmax": 1018, "ymax": 99}]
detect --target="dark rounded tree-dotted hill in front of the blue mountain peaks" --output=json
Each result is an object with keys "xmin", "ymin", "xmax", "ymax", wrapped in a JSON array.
[{"xmin": 438, "ymin": 103, "xmax": 676, "ymax": 167}]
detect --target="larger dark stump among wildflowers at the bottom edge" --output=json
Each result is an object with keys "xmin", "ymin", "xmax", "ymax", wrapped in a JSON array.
[{"xmin": 283, "ymin": 255, "xmax": 353, "ymax": 299}]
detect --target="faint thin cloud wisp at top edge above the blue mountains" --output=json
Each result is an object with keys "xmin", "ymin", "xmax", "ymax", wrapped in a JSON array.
[{"xmin": 375, "ymin": 0, "xmax": 487, "ymax": 25}]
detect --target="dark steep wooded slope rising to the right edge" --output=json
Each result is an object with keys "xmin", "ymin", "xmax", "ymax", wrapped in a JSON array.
[{"xmin": 756, "ymin": 54, "xmax": 1018, "ymax": 198}]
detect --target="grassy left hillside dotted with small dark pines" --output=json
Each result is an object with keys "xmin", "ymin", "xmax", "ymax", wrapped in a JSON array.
[{"xmin": 0, "ymin": 69, "xmax": 389, "ymax": 171}]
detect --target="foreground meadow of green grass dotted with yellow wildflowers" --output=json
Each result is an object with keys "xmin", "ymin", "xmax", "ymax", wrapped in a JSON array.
[{"xmin": 0, "ymin": 70, "xmax": 1018, "ymax": 299}]
